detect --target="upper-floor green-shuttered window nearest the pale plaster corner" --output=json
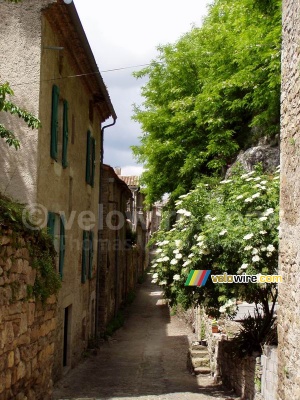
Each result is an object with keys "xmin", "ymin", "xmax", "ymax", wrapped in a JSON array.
[{"xmin": 50, "ymin": 85, "xmax": 69, "ymax": 168}]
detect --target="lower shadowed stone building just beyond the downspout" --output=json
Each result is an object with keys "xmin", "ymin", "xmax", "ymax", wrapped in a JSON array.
[{"xmin": 97, "ymin": 164, "xmax": 139, "ymax": 333}]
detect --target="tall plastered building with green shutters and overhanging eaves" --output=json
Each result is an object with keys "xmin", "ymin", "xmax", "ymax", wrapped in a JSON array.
[{"xmin": 0, "ymin": 0, "xmax": 116, "ymax": 380}]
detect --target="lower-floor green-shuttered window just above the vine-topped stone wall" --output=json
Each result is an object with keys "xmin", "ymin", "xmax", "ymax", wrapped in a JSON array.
[{"xmin": 47, "ymin": 211, "xmax": 66, "ymax": 279}]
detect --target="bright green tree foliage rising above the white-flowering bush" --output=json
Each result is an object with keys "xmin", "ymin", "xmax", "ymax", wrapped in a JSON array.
[{"xmin": 133, "ymin": 0, "xmax": 281, "ymax": 203}]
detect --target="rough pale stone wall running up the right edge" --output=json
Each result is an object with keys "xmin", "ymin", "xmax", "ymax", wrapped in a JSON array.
[{"xmin": 278, "ymin": 0, "xmax": 300, "ymax": 400}]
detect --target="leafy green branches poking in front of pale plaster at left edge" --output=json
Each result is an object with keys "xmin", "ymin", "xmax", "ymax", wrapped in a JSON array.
[{"xmin": 0, "ymin": 0, "xmax": 41, "ymax": 150}]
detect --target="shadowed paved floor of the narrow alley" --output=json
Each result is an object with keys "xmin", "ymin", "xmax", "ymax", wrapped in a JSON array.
[{"xmin": 53, "ymin": 275, "xmax": 236, "ymax": 400}]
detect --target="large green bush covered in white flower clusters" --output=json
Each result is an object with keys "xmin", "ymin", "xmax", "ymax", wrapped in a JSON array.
[{"xmin": 152, "ymin": 167, "xmax": 279, "ymax": 315}]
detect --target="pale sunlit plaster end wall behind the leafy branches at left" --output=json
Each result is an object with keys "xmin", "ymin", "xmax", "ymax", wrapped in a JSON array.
[{"xmin": 0, "ymin": 0, "xmax": 53, "ymax": 203}]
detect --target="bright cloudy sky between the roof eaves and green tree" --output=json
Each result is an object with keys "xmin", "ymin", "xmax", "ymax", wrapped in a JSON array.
[{"xmin": 74, "ymin": 0, "xmax": 212, "ymax": 175}]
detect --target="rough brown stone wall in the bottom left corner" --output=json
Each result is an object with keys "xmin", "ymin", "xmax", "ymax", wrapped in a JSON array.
[{"xmin": 0, "ymin": 231, "xmax": 56, "ymax": 400}]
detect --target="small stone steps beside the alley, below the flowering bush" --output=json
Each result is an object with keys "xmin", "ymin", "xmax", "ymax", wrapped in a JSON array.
[{"xmin": 187, "ymin": 342, "xmax": 211, "ymax": 375}]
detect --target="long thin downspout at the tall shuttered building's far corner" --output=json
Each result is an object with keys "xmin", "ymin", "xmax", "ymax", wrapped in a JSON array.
[{"xmin": 95, "ymin": 117, "xmax": 117, "ymax": 336}]
